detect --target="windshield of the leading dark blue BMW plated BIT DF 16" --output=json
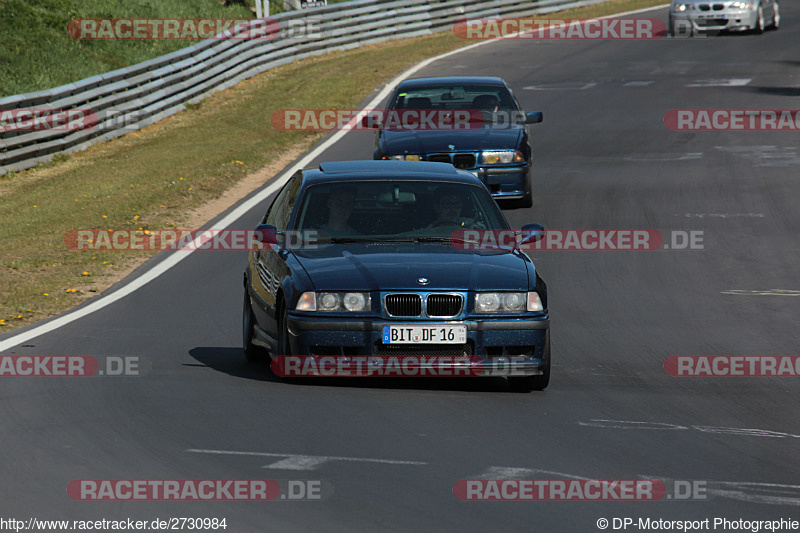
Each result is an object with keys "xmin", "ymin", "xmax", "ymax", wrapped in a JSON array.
[{"xmin": 294, "ymin": 180, "xmax": 507, "ymax": 242}]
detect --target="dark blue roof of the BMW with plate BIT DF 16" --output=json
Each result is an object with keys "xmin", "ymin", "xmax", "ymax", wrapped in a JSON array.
[{"xmin": 303, "ymin": 160, "xmax": 483, "ymax": 186}]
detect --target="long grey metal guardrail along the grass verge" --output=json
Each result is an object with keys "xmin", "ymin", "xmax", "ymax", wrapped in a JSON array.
[{"xmin": 0, "ymin": 0, "xmax": 606, "ymax": 175}]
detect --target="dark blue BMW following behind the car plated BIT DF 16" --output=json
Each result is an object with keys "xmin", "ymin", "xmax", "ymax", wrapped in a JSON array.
[{"xmin": 373, "ymin": 76, "xmax": 543, "ymax": 207}]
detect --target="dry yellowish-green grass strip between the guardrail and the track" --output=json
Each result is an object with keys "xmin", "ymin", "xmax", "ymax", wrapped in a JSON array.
[{"xmin": 0, "ymin": 0, "xmax": 660, "ymax": 332}]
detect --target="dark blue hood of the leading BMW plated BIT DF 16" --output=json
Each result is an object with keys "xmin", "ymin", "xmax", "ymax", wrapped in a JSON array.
[{"xmin": 294, "ymin": 243, "xmax": 533, "ymax": 291}]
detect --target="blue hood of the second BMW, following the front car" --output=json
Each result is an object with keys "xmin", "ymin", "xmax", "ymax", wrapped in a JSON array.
[{"xmin": 380, "ymin": 124, "xmax": 525, "ymax": 155}]
